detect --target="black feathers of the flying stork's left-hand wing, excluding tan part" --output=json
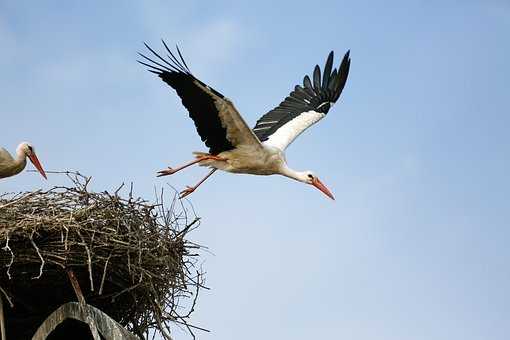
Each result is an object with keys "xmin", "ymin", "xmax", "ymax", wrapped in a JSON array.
[{"xmin": 138, "ymin": 41, "xmax": 234, "ymax": 155}]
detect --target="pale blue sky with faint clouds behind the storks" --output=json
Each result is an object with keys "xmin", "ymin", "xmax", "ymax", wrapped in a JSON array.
[{"xmin": 0, "ymin": 0, "xmax": 510, "ymax": 340}]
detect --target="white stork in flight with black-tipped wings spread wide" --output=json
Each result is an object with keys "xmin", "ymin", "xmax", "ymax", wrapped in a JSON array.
[{"xmin": 138, "ymin": 41, "xmax": 351, "ymax": 199}]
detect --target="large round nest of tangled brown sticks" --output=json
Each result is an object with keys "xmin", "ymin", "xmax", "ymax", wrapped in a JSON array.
[{"xmin": 0, "ymin": 173, "xmax": 203, "ymax": 339}]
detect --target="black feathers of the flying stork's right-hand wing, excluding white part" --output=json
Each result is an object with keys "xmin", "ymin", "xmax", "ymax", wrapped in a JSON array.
[{"xmin": 253, "ymin": 51, "xmax": 351, "ymax": 142}]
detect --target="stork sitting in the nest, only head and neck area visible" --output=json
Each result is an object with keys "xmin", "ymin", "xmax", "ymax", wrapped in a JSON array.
[{"xmin": 0, "ymin": 142, "xmax": 48, "ymax": 179}]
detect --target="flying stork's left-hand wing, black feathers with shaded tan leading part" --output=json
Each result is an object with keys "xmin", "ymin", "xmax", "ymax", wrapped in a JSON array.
[{"xmin": 138, "ymin": 41, "xmax": 261, "ymax": 155}]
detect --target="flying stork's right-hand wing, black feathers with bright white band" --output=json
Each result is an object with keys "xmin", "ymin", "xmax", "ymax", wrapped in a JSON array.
[{"xmin": 253, "ymin": 51, "xmax": 351, "ymax": 150}]
